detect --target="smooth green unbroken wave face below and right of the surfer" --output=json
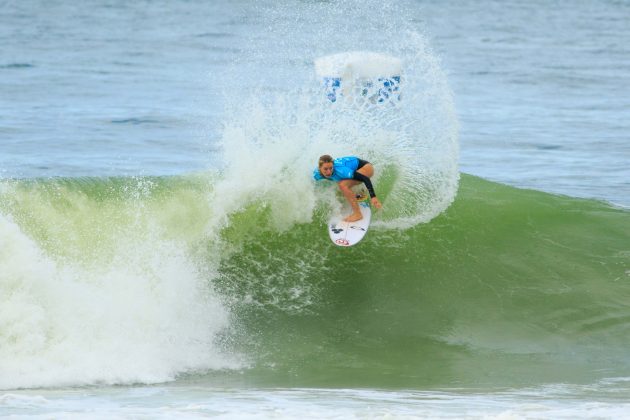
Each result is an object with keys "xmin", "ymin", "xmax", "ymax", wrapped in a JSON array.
[{"xmin": 216, "ymin": 176, "xmax": 630, "ymax": 386}]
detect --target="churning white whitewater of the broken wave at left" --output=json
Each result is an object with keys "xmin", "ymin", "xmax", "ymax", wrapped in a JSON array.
[{"xmin": 0, "ymin": 216, "xmax": 239, "ymax": 389}]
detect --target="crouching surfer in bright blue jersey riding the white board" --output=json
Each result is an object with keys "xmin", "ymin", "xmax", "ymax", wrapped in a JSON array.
[{"xmin": 313, "ymin": 155, "xmax": 382, "ymax": 222}]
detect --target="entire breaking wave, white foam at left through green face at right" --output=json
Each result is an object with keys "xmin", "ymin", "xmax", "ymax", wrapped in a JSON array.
[{"xmin": 0, "ymin": 175, "xmax": 630, "ymax": 388}]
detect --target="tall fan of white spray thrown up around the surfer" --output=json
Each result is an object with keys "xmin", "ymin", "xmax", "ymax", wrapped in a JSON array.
[{"xmin": 215, "ymin": 0, "xmax": 459, "ymax": 229}]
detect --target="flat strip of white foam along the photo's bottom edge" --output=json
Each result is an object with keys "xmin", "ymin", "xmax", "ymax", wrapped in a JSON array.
[{"xmin": 0, "ymin": 385, "xmax": 630, "ymax": 420}]
